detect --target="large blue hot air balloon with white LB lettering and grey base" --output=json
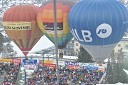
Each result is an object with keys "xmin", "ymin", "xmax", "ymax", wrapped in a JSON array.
[{"xmin": 68, "ymin": 0, "xmax": 128, "ymax": 61}]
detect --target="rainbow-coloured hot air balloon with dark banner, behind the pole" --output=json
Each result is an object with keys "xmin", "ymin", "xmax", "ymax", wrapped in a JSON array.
[{"xmin": 37, "ymin": 0, "xmax": 73, "ymax": 49}]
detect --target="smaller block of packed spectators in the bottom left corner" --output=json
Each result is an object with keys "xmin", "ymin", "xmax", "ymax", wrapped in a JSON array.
[{"xmin": 2, "ymin": 63, "xmax": 20, "ymax": 85}]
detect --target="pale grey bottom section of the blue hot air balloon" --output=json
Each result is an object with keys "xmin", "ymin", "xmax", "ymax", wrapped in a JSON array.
[{"xmin": 81, "ymin": 43, "xmax": 117, "ymax": 61}]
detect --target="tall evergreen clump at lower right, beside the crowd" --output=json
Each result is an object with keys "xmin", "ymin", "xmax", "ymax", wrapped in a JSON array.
[{"xmin": 106, "ymin": 50, "xmax": 128, "ymax": 84}]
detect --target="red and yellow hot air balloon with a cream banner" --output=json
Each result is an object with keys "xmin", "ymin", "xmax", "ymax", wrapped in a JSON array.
[{"xmin": 3, "ymin": 5, "xmax": 42, "ymax": 56}]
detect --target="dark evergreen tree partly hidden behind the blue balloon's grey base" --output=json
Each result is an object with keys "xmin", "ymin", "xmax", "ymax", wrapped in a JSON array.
[{"xmin": 78, "ymin": 46, "xmax": 94, "ymax": 63}]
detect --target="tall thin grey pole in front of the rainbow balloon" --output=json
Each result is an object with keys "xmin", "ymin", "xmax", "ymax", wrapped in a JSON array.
[{"xmin": 53, "ymin": 0, "xmax": 59, "ymax": 85}]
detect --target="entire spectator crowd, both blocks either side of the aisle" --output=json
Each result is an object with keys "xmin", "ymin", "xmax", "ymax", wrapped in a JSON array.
[{"xmin": 0, "ymin": 63, "xmax": 104, "ymax": 85}]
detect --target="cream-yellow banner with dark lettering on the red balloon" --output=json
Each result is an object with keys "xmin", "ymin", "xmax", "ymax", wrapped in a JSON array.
[{"xmin": 3, "ymin": 22, "xmax": 31, "ymax": 30}]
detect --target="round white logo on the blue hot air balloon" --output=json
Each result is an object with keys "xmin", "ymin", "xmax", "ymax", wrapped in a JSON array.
[{"xmin": 96, "ymin": 23, "xmax": 112, "ymax": 38}]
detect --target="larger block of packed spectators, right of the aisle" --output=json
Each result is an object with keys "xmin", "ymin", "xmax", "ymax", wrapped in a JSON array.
[{"xmin": 24, "ymin": 66, "xmax": 104, "ymax": 85}]
